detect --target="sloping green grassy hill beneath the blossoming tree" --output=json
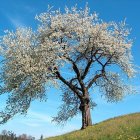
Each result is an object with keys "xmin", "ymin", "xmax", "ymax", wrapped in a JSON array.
[{"xmin": 46, "ymin": 113, "xmax": 140, "ymax": 140}]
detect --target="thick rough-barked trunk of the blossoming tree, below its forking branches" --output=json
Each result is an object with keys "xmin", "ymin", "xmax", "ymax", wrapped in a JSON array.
[{"xmin": 79, "ymin": 99, "xmax": 92, "ymax": 129}]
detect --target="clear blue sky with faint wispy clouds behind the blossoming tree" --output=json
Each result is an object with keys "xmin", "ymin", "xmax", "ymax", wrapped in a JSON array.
[{"xmin": 0, "ymin": 0, "xmax": 140, "ymax": 138}]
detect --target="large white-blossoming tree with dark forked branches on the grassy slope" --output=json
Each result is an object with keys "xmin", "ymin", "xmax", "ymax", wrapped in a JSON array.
[{"xmin": 0, "ymin": 6, "xmax": 135, "ymax": 129}]
